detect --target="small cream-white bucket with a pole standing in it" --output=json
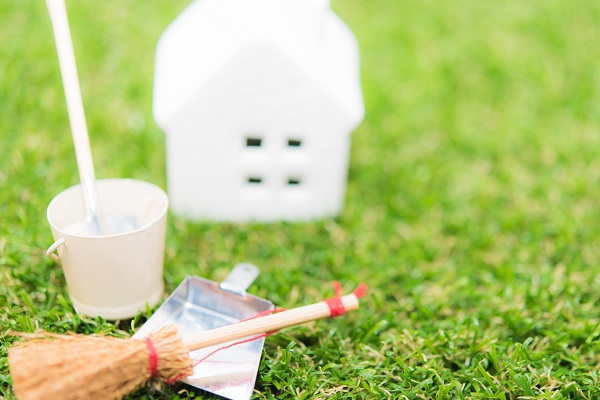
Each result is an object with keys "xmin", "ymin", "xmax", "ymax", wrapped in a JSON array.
[{"xmin": 47, "ymin": 179, "xmax": 169, "ymax": 320}]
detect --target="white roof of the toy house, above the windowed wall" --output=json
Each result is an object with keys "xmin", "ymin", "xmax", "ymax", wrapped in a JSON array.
[{"xmin": 154, "ymin": 0, "xmax": 364, "ymax": 130}]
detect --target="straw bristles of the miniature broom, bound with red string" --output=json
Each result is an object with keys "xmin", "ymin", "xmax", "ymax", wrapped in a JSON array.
[{"xmin": 8, "ymin": 326, "xmax": 193, "ymax": 400}]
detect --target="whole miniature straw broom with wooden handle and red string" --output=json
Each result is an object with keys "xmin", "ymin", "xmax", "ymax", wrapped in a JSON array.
[{"xmin": 8, "ymin": 286, "xmax": 364, "ymax": 400}]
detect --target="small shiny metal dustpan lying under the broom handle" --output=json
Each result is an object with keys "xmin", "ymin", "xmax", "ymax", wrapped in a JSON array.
[{"xmin": 133, "ymin": 264, "xmax": 274, "ymax": 400}]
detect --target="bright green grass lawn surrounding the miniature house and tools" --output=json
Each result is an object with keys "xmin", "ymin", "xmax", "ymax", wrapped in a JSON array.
[{"xmin": 0, "ymin": 0, "xmax": 600, "ymax": 399}]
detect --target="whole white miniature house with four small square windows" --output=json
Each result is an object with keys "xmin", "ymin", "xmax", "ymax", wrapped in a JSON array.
[{"xmin": 153, "ymin": 0, "xmax": 364, "ymax": 221}]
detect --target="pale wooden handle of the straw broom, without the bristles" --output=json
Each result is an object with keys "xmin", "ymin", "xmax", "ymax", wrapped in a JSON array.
[{"xmin": 184, "ymin": 293, "xmax": 358, "ymax": 351}]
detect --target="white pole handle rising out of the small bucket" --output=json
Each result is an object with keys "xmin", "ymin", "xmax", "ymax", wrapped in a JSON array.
[{"xmin": 46, "ymin": 0, "xmax": 95, "ymax": 181}]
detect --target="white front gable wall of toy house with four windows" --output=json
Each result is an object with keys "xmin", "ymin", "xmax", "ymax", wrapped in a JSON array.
[{"xmin": 159, "ymin": 43, "xmax": 356, "ymax": 221}]
